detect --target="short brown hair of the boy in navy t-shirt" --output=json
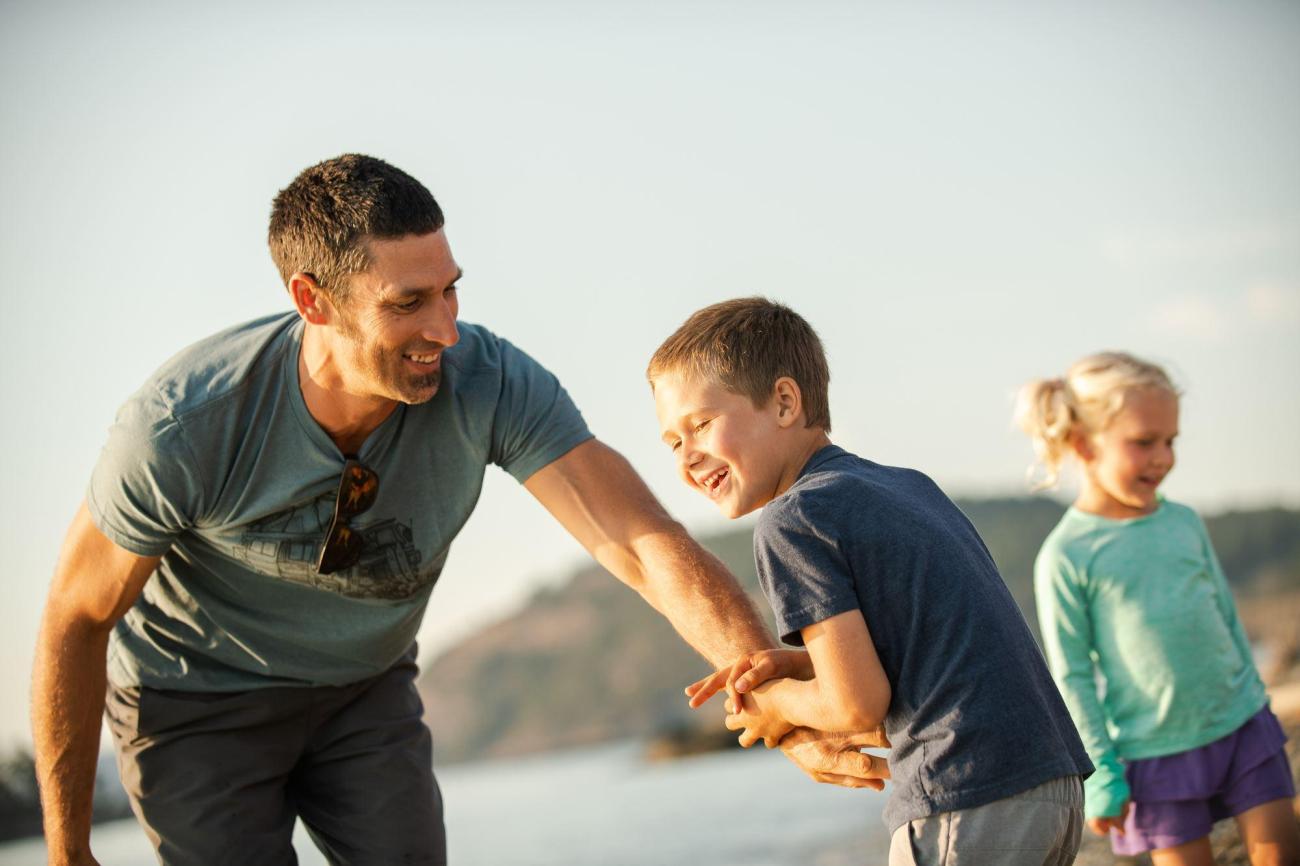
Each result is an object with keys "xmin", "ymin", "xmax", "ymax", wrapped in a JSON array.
[{"xmin": 646, "ymin": 298, "xmax": 831, "ymax": 433}]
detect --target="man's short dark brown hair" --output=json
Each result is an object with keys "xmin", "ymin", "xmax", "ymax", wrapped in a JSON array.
[{"xmin": 267, "ymin": 153, "xmax": 443, "ymax": 302}]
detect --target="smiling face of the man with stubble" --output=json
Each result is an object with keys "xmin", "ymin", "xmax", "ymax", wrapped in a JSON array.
[{"xmin": 334, "ymin": 229, "xmax": 460, "ymax": 403}]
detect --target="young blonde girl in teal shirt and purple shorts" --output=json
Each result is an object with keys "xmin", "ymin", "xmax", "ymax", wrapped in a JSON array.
[{"xmin": 1017, "ymin": 352, "xmax": 1300, "ymax": 866}]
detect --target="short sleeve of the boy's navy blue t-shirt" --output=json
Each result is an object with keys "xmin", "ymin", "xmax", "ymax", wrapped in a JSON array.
[{"xmin": 754, "ymin": 497, "xmax": 859, "ymax": 646}]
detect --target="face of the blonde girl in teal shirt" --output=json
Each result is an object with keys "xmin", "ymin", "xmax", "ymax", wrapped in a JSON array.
[{"xmin": 1074, "ymin": 387, "xmax": 1178, "ymax": 519}]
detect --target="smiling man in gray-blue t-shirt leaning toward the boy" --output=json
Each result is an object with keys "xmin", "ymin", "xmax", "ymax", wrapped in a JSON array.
[{"xmin": 33, "ymin": 155, "xmax": 880, "ymax": 865}]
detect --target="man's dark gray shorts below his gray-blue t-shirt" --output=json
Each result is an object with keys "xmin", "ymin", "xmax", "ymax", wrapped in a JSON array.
[{"xmin": 107, "ymin": 650, "xmax": 447, "ymax": 866}]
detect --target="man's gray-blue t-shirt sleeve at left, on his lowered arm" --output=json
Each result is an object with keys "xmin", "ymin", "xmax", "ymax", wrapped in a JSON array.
[{"xmin": 86, "ymin": 398, "xmax": 203, "ymax": 557}]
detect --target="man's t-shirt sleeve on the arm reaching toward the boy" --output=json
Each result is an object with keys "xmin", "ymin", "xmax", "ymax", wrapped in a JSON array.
[{"xmin": 489, "ymin": 337, "xmax": 592, "ymax": 482}]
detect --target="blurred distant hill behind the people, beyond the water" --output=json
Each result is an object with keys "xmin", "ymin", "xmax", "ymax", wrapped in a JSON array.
[{"xmin": 420, "ymin": 497, "xmax": 1300, "ymax": 762}]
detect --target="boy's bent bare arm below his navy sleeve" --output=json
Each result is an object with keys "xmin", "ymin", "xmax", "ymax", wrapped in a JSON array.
[{"xmin": 727, "ymin": 610, "xmax": 892, "ymax": 748}]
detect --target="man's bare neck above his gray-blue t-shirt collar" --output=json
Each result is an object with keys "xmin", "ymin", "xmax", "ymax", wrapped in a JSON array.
[{"xmin": 298, "ymin": 326, "xmax": 398, "ymax": 454}]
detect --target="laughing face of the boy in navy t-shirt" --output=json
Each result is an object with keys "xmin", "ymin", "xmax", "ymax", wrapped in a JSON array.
[{"xmin": 654, "ymin": 373, "xmax": 788, "ymax": 518}]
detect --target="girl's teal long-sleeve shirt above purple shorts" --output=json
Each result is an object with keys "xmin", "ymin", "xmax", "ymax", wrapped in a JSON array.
[{"xmin": 1034, "ymin": 501, "xmax": 1268, "ymax": 818}]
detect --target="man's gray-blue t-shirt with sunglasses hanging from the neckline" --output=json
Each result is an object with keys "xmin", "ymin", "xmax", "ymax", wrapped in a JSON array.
[{"xmin": 86, "ymin": 312, "xmax": 592, "ymax": 692}]
